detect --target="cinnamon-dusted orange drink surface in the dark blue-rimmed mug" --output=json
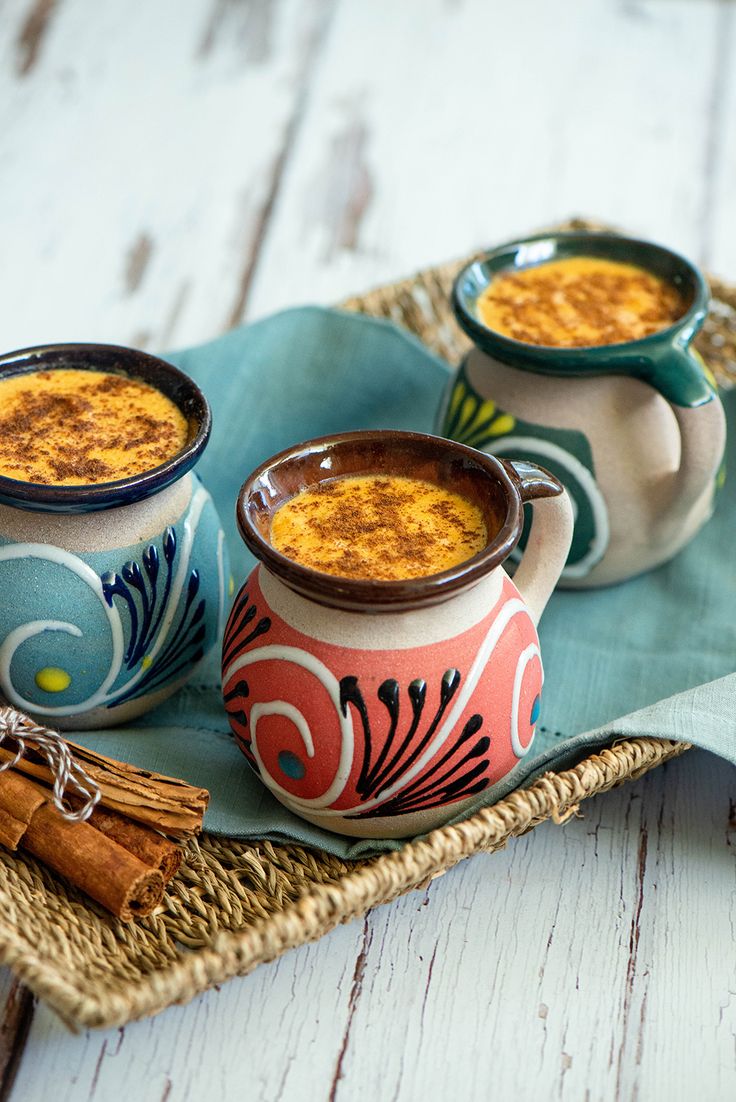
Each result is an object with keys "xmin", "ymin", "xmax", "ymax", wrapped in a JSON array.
[{"xmin": 0, "ymin": 368, "xmax": 188, "ymax": 486}]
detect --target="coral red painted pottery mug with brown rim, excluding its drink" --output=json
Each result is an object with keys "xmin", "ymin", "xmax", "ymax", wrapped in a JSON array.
[{"xmin": 223, "ymin": 431, "xmax": 572, "ymax": 838}]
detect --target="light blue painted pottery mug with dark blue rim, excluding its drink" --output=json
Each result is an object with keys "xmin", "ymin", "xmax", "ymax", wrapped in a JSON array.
[{"xmin": 0, "ymin": 345, "xmax": 229, "ymax": 728}]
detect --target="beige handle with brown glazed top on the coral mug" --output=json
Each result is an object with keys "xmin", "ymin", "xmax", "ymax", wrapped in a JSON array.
[{"xmin": 500, "ymin": 460, "xmax": 573, "ymax": 626}]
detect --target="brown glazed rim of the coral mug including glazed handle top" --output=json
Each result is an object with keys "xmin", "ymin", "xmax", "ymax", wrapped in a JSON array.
[{"xmin": 236, "ymin": 430, "xmax": 562, "ymax": 613}]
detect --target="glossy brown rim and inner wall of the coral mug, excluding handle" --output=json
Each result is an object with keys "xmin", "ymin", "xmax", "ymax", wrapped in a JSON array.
[{"xmin": 237, "ymin": 430, "xmax": 522, "ymax": 613}]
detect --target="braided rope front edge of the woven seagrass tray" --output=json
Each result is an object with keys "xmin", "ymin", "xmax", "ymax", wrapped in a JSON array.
[{"xmin": 0, "ymin": 738, "xmax": 690, "ymax": 1029}]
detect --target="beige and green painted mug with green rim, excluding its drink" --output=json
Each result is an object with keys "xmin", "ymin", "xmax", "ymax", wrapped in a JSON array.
[{"xmin": 439, "ymin": 234, "xmax": 725, "ymax": 587}]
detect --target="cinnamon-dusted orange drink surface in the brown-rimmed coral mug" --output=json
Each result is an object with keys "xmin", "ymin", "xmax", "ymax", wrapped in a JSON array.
[{"xmin": 271, "ymin": 475, "xmax": 488, "ymax": 581}]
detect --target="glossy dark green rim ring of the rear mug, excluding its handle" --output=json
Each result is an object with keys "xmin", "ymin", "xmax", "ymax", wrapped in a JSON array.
[{"xmin": 453, "ymin": 233, "xmax": 708, "ymax": 366}]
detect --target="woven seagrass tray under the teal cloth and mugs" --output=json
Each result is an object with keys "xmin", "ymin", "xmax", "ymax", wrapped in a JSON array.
[{"xmin": 0, "ymin": 222, "xmax": 736, "ymax": 1029}]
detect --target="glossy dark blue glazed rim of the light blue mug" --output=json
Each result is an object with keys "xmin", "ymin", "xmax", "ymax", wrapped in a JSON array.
[{"xmin": 0, "ymin": 344, "xmax": 212, "ymax": 512}]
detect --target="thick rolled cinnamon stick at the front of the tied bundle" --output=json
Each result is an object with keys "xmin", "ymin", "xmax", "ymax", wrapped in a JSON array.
[{"xmin": 0, "ymin": 771, "xmax": 164, "ymax": 921}]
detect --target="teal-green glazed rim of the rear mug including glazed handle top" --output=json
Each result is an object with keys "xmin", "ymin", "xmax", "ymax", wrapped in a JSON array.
[{"xmin": 452, "ymin": 233, "xmax": 715, "ymax": 408}]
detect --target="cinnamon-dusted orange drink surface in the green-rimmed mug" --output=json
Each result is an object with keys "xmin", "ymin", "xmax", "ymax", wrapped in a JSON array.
[{"xmin": 478, "ymin": 257, "xmax": 685, "ymax": 348}]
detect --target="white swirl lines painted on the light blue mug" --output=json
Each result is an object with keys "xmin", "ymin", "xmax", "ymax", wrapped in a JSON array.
[{"xmin": 0, "ymin": 486, "xmax": 218, "ymax": 717}]
